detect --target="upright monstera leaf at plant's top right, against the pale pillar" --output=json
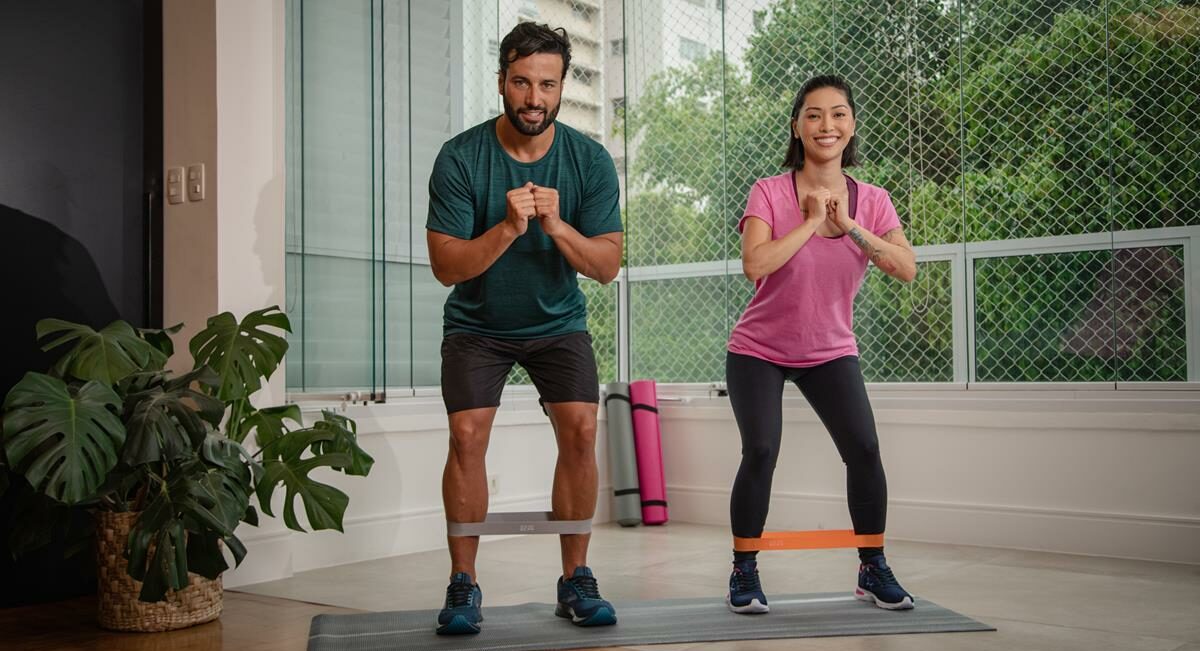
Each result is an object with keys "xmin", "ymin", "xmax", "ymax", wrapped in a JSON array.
[{"xmin": 188, "ymin": 307, "xmax": 292, "ymax": 401}]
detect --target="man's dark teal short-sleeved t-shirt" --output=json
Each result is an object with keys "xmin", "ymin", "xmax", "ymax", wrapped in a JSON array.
[{"xmin": 425, "ymin": 115, "xmax": 622, "ymax": 339}]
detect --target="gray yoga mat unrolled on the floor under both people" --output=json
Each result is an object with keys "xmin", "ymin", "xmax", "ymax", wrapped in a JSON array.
[{"xmin": 308, "ymin": 592, "xmax": 995, "ymax": 651}]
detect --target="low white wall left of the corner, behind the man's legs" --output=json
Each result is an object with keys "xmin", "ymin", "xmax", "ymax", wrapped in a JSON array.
[{"xmin": 224, "ymin": 395, "xmax": 611, "ymax": 587}]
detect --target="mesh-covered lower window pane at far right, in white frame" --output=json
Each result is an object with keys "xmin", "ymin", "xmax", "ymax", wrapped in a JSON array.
[{"xmin": 974, "ymin": 247, "xmax": 1187, "ymax": 382}]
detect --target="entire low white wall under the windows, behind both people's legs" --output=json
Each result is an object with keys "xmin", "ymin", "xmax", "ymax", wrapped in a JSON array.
[{"xmin": 227, "ymin": 389, "xmax": 1200, "ymax": 586}]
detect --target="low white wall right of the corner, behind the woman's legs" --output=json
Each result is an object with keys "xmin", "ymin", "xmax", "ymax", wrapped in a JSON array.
[{"xmin": 661, "ymin": 390, "xmax": 1200, "ymax": 563}]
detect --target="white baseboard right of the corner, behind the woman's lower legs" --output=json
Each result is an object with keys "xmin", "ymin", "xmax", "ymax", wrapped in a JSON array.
[{"xmin": 667, "ymin": 485, "xmax": 1200, "ymax": 565}]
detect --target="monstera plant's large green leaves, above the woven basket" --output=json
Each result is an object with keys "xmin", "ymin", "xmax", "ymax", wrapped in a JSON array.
[{"xmin": 0, "ymin": 307, "xmax": 373, "ymax": 602}]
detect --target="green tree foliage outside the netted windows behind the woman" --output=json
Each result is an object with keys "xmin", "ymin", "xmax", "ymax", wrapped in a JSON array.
[{"xmin": 614, "ymin": 0, "xmax": 1200, "ymax": 381}]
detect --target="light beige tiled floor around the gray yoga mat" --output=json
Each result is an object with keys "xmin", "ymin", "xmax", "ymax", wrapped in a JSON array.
[{"xmin": 239, "ymin": 524, "xmax": 1200, "ymax": 651}]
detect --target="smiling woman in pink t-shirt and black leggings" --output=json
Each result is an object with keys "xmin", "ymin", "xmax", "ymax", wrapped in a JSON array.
[{"xmin": 726, "ymin": 76, "xmax": 917, "ymax": 613}]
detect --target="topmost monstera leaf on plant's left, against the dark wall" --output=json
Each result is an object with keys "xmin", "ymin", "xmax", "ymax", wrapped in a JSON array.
[{"xmin": 37, "ymin": 318, "xmax": 167, "ymax": 386}]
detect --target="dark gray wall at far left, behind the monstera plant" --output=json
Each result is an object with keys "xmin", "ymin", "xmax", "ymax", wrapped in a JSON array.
[{"xmin": 0, "ymin": 0, "xmax": 162, "ymax": 610}]
